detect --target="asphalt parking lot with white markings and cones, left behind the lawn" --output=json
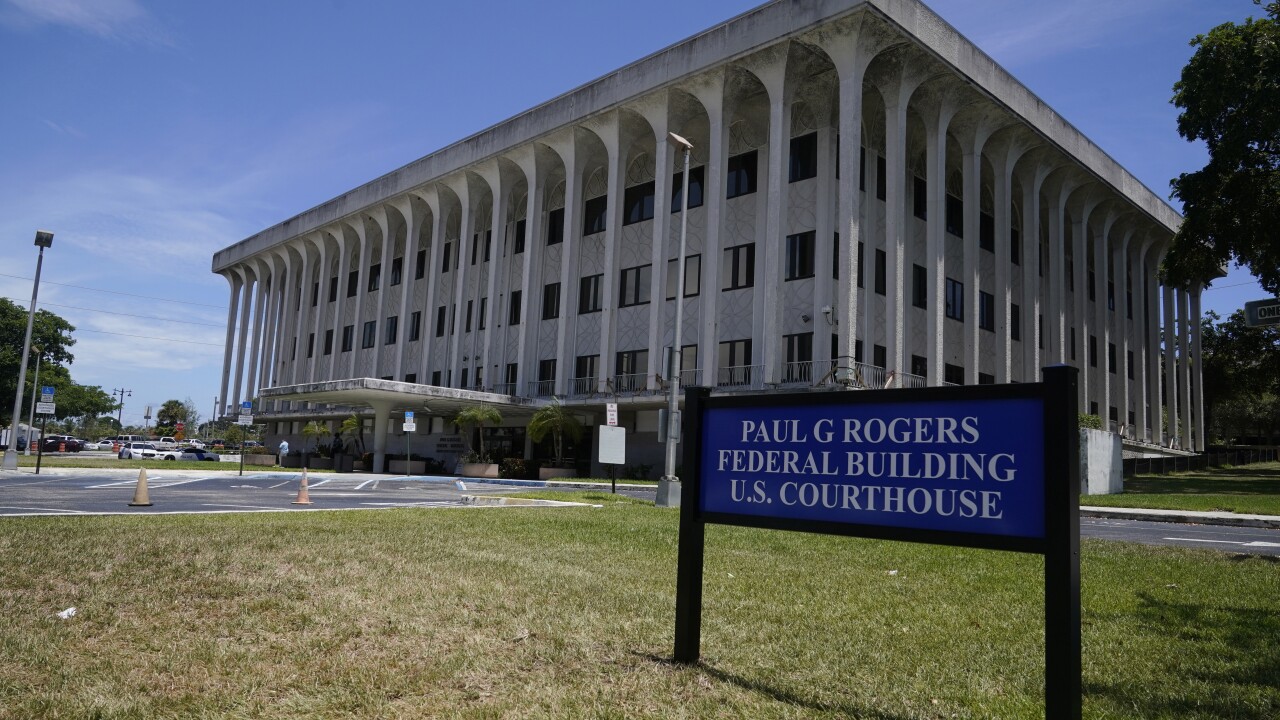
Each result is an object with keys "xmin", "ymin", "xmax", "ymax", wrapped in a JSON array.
[{"xmin": 0, "ymin": 468, "xmax": 535, "ymax": 516}]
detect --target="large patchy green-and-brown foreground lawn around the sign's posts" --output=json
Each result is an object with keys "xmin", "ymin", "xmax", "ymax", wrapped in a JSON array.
[{"xmin": 0, "ymin": 492, "xmax": 1280, "ymax": 720}]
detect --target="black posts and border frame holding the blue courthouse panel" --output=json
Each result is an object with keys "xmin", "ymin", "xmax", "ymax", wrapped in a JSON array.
[{"xmin": 673, "ymin": 365, "xmax": 1083, "ymax": 720}]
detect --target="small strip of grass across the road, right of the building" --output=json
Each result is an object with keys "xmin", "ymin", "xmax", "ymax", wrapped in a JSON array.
[{"xmin": 1080, "ymin": 462, "xmax": 1280, "ymax": 515}]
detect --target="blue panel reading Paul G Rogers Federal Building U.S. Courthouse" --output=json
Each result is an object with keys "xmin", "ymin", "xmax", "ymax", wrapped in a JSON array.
[{"xmin": 699, "ymin": 397, "xmax": 1044, "ymax": 538}]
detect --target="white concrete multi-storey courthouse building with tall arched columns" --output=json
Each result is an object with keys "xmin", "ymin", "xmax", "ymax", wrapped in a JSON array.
[{"xmin": 212, "ymin": 0, "xmax": 1204, "ymax": 477}]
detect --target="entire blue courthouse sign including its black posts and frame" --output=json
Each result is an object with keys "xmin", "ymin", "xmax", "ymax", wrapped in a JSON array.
[{"xmin": 675, "ymin": 365, "xmax": 1082, "ymax": 720}]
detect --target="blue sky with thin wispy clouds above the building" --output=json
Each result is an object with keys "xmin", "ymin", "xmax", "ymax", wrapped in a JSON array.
[{"xmin": 0, "ymin": 0, "xmax": 1266, "ymax": 423}]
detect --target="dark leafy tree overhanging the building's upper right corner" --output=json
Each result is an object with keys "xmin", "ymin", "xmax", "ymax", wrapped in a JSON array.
[{"xmin": 1164, "ymin": 0, "xmax": 1280, "ymax": 295}]
